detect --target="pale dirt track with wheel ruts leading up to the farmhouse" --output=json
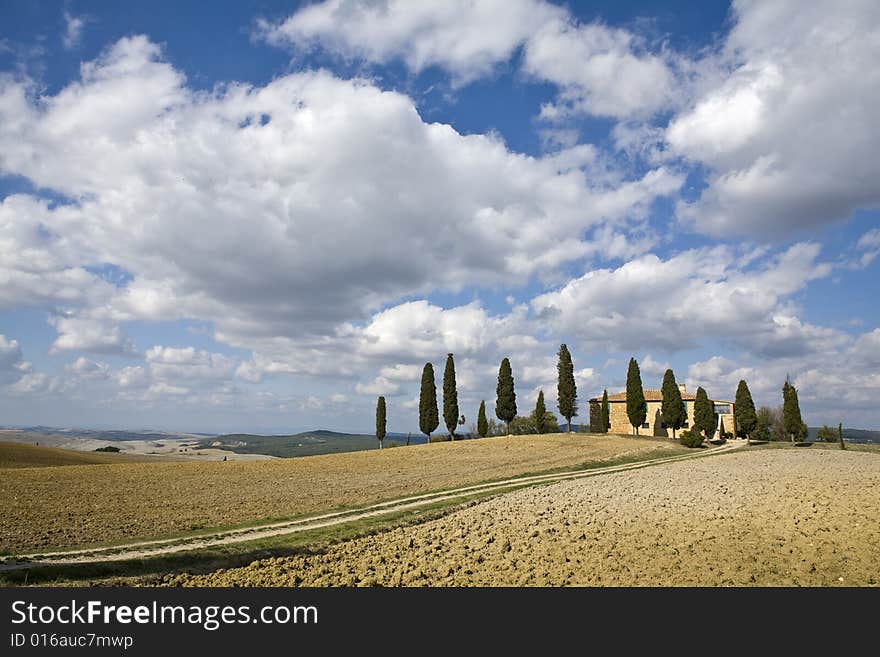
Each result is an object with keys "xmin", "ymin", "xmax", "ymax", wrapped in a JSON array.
[{"xmin": 0, "ymin": 441, "xmax": 744, "ymax": 572}]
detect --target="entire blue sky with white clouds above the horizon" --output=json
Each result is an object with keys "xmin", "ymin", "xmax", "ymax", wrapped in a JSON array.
[{"xmin": 0, "ymin": 0, "xmax": 880, "ymax": 432}]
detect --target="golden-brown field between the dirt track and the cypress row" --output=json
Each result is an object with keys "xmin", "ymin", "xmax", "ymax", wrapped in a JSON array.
[{"xmin": 0, "ymin": 433, "xmax": 686, "ymax": 554}]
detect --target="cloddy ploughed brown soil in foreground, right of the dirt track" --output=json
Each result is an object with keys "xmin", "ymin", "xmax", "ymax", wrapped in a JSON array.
[{"xmin": 163, "ymin": 448, "xmax": 880, "ymax": 586}]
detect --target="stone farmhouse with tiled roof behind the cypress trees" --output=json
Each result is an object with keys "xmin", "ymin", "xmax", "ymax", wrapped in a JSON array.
[{"xmin": 590, "ymin": 383, "xmax": 734, "ymax": 438}]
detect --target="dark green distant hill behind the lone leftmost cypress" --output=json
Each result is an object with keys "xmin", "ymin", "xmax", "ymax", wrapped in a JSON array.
[{"xmin": 197, "ymin": 429, "xmax": 425, "ymax": 458}]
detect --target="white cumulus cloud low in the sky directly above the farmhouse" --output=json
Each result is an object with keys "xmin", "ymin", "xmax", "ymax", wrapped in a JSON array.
[{"xmin": 532, "ymin": 243, "xmax": 837, "ymax": 356}]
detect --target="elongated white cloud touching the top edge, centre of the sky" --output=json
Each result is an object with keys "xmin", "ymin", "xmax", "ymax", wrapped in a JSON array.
[{"xmin": 259, "ymin": 0, "xmax": 674, "ymax": 119}]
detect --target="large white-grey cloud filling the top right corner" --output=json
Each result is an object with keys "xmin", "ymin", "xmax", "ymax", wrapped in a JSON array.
[{"xmin": 666, "ymin": 0, "xmax": 880, "ymax": 237}]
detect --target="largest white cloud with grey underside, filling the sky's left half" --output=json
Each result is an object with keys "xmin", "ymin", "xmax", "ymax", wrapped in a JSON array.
[{"xmin": 0, "ymin": 36, "xmax": 682, "ymax": 358}]
